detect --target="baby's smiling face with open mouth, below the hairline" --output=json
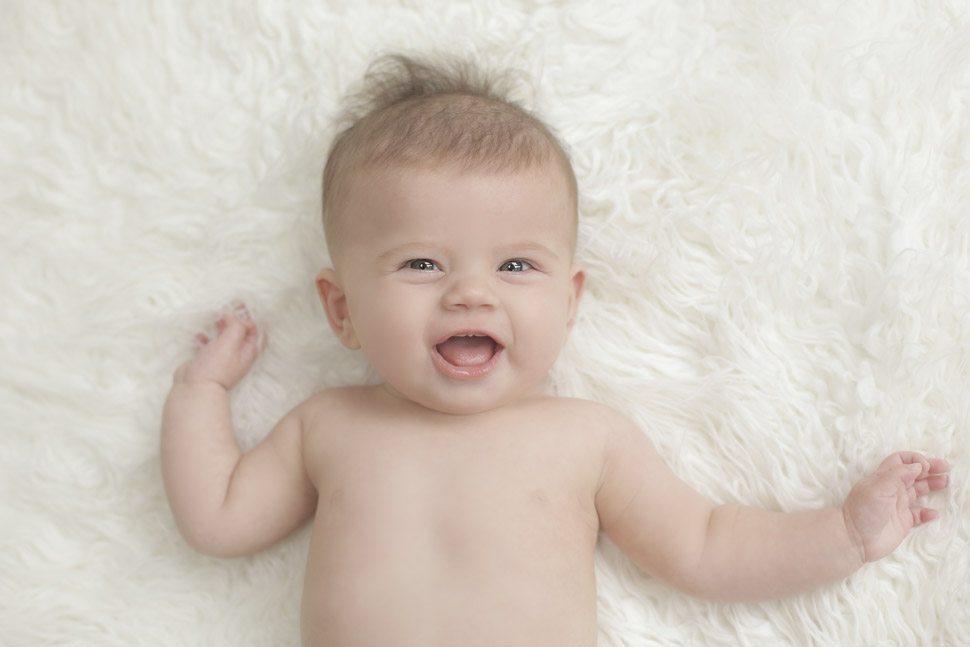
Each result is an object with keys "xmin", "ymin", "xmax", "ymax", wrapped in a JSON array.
[{"xmin": 321, "ymin": 165, "xmax": 584, "ymax": 413}]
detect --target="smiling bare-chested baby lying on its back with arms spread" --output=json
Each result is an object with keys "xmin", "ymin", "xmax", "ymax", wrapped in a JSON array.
[{"xmin": 161, "ymin": 57, "xmax": 949, "ymax": 647}]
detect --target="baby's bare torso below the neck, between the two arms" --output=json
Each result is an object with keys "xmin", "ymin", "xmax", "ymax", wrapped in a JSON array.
[{"xmin": 304, "ymin": 412, "xmax": 598, "ymax": 644}]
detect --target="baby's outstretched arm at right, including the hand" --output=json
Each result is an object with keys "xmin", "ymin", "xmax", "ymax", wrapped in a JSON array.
[{"xmin": 596, "ymin": 422, "xmax": 949, "ymax": 600}]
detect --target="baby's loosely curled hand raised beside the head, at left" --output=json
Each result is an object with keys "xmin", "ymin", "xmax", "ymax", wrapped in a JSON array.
[{"xmin": 175, "ymin": 305, "xmax": 266, "ymax": 391}]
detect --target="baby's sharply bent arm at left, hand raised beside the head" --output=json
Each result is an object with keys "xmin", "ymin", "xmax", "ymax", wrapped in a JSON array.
[{"xmin": 161, "ymin": 310, "xmax": 316, "ymax": 557}]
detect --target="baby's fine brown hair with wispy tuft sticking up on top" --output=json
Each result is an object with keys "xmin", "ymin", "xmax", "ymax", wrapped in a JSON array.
[{"xmin": 323, "ymin": 54, "xmax": 577, "ymax": 252}]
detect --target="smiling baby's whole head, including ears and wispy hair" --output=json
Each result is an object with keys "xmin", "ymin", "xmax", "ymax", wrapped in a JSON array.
[{"xmin": 317, "ymin": 57, "xmax": 584, "ymax": 413}]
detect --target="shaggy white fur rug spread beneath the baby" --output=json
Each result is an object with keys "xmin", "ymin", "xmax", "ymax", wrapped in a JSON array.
[{"xmin": 0, "ymin": 0, "xmax": 970, "ymax": 647}]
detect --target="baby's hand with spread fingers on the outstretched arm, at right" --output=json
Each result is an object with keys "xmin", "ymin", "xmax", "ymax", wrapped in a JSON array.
[{"xmin": 842, "ymin": 452, "xmax": 950, "ymax": 562}]
